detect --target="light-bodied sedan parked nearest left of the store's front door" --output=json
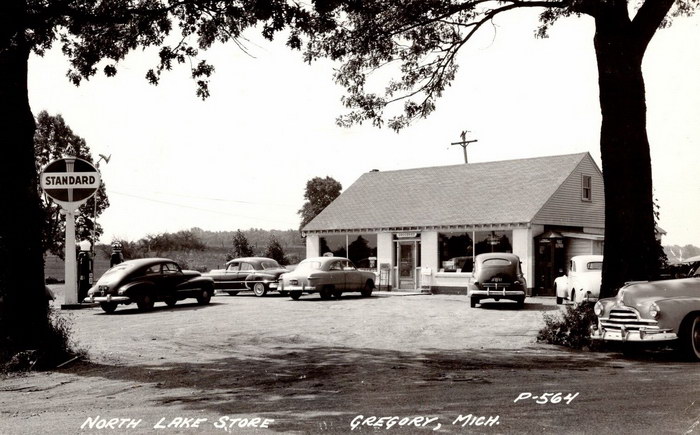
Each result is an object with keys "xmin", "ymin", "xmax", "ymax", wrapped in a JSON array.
[{"xmin": 279, "ymin": 257, "xmax": 376, "ymax": 300}]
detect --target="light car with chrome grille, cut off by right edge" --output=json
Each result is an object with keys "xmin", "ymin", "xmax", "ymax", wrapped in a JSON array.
[{"xmin": 591, "ymin": 271, "xmax": 700, "ymax": 361}]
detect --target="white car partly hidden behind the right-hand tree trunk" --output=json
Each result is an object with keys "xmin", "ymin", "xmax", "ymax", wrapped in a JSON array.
[{"xmin": 554, "ymin": 255, "xmax": 603, "ymax": 306}]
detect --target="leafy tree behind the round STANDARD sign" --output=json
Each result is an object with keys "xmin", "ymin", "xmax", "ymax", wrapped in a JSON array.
[{"xmin": 34, "ymin": 110, "xmax": 109, "ymax": 258}]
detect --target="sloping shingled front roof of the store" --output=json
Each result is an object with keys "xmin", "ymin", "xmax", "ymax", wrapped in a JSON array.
[{"xmin": 303, "ymin": 153, "xmax": 592, "ymax": 235}]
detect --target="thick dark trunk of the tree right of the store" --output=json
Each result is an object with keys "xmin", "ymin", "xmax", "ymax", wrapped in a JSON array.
[{"xmin": 594, "ymin": 13, "xmax": 658, "ymax": 297}]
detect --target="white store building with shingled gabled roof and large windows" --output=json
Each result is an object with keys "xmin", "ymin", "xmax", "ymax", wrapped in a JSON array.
[{"xmin": 303, "ymin": 153, "xmax": 605, "ymax": 295}]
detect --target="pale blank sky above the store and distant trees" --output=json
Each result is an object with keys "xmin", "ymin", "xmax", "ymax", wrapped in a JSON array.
[{"xmin": 29, "ymin": 11, "xmax": 700, "ymax": 246}]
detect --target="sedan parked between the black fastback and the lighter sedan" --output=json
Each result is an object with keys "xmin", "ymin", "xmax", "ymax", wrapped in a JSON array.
[{"xmin": 204, "ymin": 257, "xmax": 289, "ymax": 296}]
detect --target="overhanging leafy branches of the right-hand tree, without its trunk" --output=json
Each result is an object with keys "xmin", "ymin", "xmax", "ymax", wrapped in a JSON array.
[{"xmin": 288, "ymin": 0, "xmax": 700, "ymax": 131}]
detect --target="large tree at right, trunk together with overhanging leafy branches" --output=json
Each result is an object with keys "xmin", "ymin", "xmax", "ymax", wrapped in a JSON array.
[{"xmin": 288, "ymin": 0, "xmax": 700, "ymax": 296}]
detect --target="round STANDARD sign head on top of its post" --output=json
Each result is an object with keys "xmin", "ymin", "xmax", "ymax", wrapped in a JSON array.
[{"xmin": 40, "ymin": 157, "xmax": 100, "ymax": 208}]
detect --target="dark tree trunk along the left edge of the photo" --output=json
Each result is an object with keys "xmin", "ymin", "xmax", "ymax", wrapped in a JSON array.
[{"xmin": 0, "ymin": 0, "xmax": 48, "ymax": 350}]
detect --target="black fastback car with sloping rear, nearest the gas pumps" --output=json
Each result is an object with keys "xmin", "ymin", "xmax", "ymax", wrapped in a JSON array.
[{"xmin": 85, "ymin": 258, "xmax": 214, "ymax": 313}]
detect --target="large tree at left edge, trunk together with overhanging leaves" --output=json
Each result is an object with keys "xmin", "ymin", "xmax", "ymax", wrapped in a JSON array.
[{"xmin": 0, "ymin": 0, "xmax": 306, "ymax": 358}]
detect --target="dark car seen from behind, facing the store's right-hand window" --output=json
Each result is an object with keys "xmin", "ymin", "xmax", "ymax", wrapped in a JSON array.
[{"xmin": 467, "ymin": 252, "xmax": 527, "ymax": 308}]
